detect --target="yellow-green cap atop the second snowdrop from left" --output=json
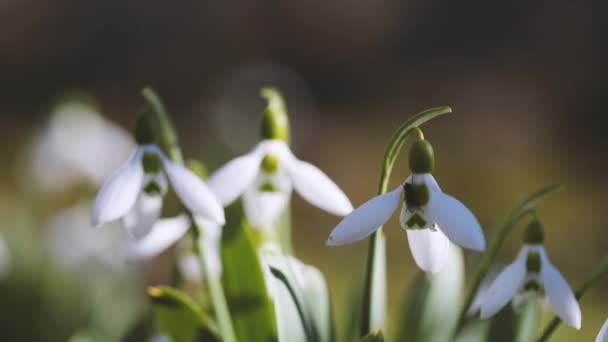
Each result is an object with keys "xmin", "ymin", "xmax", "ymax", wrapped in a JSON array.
[{"xmin": 260, "ymin": 88, "xmax": 289, "ymax": 142}]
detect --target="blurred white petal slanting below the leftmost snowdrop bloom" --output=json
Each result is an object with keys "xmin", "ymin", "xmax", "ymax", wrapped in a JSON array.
[{"xmin": 127, "ymin": 215, "xmax": 190, "ymax": 259}]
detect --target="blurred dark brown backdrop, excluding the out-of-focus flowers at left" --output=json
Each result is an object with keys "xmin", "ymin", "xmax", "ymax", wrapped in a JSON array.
[{"xmin": 0, "ymin": 0, "xmax": 608, "ymax": 341}]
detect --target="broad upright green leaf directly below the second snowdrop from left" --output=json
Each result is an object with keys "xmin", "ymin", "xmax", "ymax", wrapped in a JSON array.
[{"xmin": 221, "ymin": 202, "xmax": 277, "ymax": 341}]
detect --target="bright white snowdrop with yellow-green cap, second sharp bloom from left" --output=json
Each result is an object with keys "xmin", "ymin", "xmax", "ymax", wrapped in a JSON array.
[{"xmin": 209, "ymin": 89, "xmax": 352, "ymax": 228}]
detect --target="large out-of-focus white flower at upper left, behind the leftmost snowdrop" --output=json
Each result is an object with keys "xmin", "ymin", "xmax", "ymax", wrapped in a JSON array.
[{"xmin": 27, "ymin": 101, "xmax": 135, "ymax": 191}]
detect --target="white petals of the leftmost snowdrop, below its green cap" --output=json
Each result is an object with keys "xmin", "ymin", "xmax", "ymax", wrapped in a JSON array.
[{"xmin": 91, "ymin": 144, "xmax": 225, "ymax": 239}]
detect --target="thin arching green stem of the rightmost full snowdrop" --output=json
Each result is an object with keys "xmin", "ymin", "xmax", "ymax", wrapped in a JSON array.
[{"xmin": 454, "ymin": 184, "xmax": 562, "ymax": 336}]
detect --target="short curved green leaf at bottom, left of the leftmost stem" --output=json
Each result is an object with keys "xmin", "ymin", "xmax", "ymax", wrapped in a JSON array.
[{"xmin": 148, "ymin": 286, "xmax": 220, "ymax": 342}]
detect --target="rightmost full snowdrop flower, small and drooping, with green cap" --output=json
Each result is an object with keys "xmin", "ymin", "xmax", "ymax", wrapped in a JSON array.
[{"xmin": 481, "ymin": 220, "xmax": 581, "ymax": 329}]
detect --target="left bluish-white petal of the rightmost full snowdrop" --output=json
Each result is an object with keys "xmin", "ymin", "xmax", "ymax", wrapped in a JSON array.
[{"xmin": 481, "ymin": 247, "xmax": 528, "ymax": 319}]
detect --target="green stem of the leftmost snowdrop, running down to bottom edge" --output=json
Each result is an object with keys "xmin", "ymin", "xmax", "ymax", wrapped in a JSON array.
[{"xmin": 142, "ymin": 87, "xmax": 236, "ymax": 342}]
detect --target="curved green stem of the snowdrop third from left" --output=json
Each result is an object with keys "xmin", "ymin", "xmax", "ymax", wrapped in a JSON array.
[{"xmin": 360, "ymin": 107, "xmax": 452, "ymax": 336}]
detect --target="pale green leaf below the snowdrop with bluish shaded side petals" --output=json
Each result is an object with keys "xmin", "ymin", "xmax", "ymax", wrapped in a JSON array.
[{"xmin": 396, "ymin": 244, "xmax": 464, "ymax": 342}]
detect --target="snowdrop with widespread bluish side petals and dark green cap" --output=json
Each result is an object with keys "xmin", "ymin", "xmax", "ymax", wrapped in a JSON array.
[{"xmin": 327, "ymin": 139, "xmax": 485, "ymax": 273}]
